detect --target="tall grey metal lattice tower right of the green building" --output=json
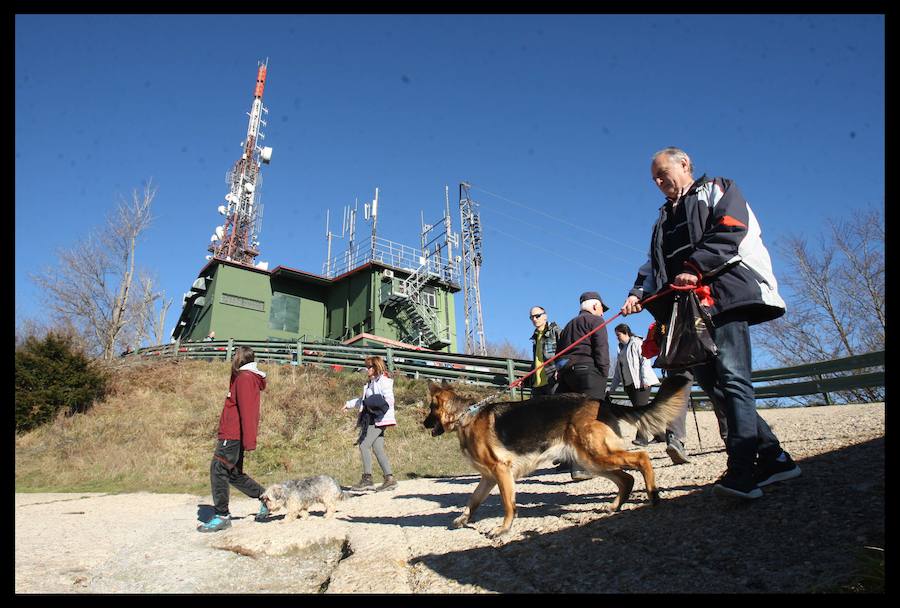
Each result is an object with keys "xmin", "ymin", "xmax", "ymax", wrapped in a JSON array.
[{"xmin": 459, "ymin": 182, "xmax": 487, "ymax": 355}]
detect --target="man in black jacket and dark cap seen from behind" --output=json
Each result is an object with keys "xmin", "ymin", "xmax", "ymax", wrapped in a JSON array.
[{"xmin": 556, "ymin": 291, "xmax": 609, "ymax": 481}]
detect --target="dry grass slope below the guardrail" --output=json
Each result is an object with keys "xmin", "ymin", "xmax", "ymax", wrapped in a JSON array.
[{"xmin": 15, "ymin": 360, "xmax": 500, "ymax": 493}]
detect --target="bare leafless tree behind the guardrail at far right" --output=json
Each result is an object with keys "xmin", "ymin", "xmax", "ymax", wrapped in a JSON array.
[{"xmin": 754, "ymin": 204, "xmax": 885, "ymax": 403}]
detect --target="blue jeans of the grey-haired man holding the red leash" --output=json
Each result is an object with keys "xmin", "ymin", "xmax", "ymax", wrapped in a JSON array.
[{"xmin": 679, "ymin": 321, "xmax": 781, "ymax": 475}]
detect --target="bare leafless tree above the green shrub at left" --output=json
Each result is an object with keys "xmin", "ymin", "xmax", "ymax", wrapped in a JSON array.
[{"xmin": 32, "ymin": 181, "xmax": 162, "ymax": 359}]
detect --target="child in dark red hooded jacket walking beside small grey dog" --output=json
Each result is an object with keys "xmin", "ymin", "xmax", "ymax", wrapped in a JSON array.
[{"xmin": 197, "ymin": 346, "xmax": 269, "ymax": 532}]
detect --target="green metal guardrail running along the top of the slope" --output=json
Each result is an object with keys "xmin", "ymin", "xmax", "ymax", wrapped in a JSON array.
[{"xmin": 127, "ymin": 339, "xmax": 884, "ymax": 403}]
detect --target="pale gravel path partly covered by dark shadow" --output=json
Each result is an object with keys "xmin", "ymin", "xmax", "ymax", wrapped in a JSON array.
[{"xmin": 15, "ymin": 404, "xmax": 884, "ymax": 593}]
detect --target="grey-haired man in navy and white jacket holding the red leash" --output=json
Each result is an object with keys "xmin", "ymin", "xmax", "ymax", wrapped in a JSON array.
[{"xmin": 622, "ymin": 148, "xmax": 800, "ymax": 499}]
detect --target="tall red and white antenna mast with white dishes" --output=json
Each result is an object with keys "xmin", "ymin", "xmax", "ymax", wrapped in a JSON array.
[{"xmin": 207, "ymin": 58, "xmax": 272, "ymax": 266}]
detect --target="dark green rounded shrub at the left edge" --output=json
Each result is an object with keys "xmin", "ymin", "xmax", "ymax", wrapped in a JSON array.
[{"xmin": 16, "ymin": 332, "xmax": 107, "ymax": 433}]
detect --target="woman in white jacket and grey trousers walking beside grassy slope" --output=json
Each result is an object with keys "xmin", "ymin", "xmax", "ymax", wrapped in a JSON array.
[{"xmin": 344, "ymin": 356, "xmax": 397, "ymax": 492}]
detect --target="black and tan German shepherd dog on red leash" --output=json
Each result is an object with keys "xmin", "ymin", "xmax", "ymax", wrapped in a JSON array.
[{"xmin": 423, "ymin": 377, "xmax": 691, "ymax": 538}]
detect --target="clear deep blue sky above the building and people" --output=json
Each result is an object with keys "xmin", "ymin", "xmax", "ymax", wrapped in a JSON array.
[{"xmin": 15, "ymin": 15, "xmax": 885, "ymax": 365}]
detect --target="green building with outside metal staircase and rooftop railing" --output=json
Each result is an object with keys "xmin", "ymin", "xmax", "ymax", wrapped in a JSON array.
[{"xmin": 172, "ymin": 255, "xmax": 460, "ymax": 352}]
